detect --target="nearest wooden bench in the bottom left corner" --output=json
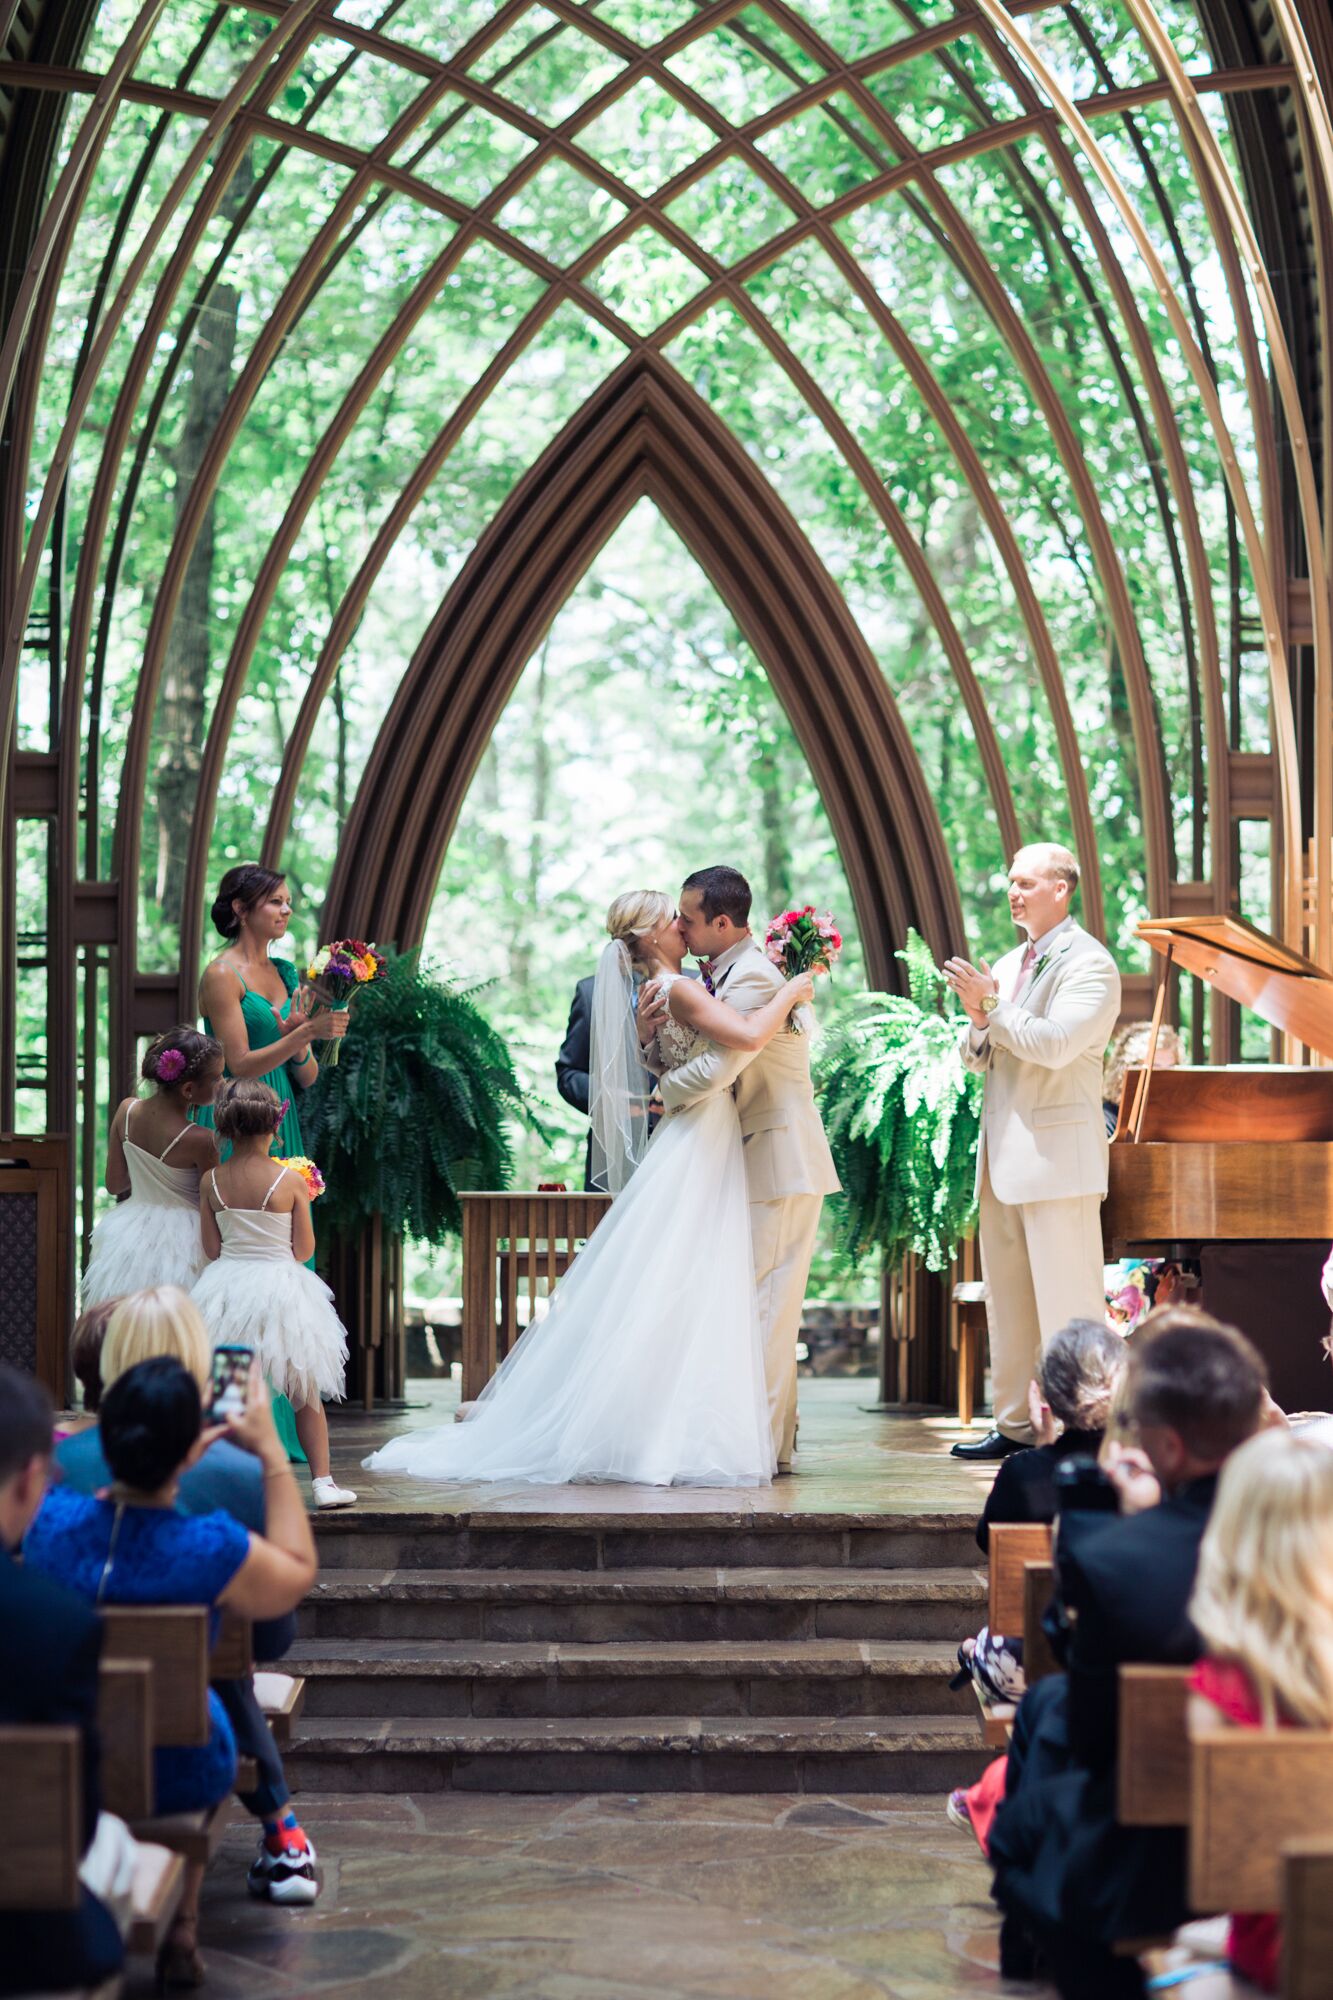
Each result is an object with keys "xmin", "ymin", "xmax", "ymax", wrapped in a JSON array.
[{"xmin": 0, "ymin": 1724, "xmax": 184, "ymax": 1976}]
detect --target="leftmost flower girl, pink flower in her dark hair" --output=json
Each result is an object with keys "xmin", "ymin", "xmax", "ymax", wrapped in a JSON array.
[{"xmin": 80, "ymin": 1028, "xmax": 222, "ymax": 1312}]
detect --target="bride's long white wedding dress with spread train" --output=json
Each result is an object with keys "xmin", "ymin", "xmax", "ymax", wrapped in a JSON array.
[{"xmin": 364, "ymin": 972, "xmax": 775, "ymax": 1486}]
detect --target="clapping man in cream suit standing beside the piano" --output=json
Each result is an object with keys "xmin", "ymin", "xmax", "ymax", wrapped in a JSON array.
[{"xmin": 945, "ymin": 844, "xmax": 1121, "ymax": 1460}]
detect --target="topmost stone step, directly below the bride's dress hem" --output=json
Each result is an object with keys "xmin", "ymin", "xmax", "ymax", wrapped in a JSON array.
[{"xmin": 316, "ymin": 1506, "xmax": 977, "ymax": 1572}]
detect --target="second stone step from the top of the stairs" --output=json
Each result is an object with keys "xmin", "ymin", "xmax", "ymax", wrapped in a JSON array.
[{"xmin": 300, "ymin": 1564, "xmax": 987, "ymax": 1644}]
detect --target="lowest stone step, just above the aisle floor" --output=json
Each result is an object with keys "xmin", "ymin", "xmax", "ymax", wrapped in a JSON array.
[{"xmin": 286, "ymin": 1708, "xmax": 991, "ymax": 1810}]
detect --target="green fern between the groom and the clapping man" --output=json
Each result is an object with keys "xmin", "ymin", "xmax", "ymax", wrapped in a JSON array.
[{"xmin": 819, "ymin": 930, "xmax": 981, "ymax": 1270}]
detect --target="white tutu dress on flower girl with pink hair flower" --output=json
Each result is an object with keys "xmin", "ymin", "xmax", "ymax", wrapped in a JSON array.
[{"xmin": 78, "ymin": 1104, "xmax": 208, "ymax": 1312}]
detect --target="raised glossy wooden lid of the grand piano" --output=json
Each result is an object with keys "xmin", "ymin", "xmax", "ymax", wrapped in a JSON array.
[{"xmin": 1137, "ymin": 916, "xmax": 1333, "ymax": 1056}]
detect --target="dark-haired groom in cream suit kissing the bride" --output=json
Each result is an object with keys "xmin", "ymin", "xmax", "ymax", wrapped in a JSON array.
[{"xmin": 638, "ymin": 868, "xmax": 839, "ymax": 1472}]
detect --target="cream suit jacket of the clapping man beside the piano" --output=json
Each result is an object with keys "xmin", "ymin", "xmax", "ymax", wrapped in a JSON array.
[{"xmin": 961, "ymin": 920, "xmax": 1121, "ymax": 1206}]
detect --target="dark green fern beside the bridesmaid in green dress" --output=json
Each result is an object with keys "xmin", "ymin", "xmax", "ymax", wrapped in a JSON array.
[{"xmin": 300, "ymin": 952, "xmax": 540, "ymax": 1248}]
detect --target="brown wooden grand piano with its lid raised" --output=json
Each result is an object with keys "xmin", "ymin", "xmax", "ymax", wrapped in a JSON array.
[{"xmin": 1103, "ymin": 916, "xmax": 1333, "ymax": 1410}]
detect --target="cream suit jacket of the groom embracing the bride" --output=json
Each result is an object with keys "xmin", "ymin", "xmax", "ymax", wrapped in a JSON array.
[{"xmin": 662, "ymin": 938, "xmax": 841, "ymax": 1202}]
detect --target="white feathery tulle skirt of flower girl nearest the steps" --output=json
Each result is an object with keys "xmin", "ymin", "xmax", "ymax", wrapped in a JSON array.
[{"xmin": 194, "ymin": 1254, "xmax": 346, "ymax": 1410}]
